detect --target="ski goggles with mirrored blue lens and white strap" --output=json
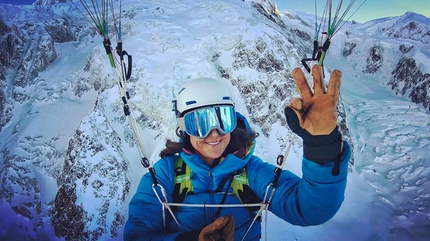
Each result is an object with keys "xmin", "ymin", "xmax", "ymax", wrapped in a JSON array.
[{"xmin": 177, "ymin": 105, "xmax": 236, "ymax": 139}]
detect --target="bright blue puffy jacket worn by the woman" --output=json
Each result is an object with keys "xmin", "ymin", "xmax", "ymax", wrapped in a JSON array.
[{"xmin": 124, "ymin": 115, "xmax": 351, "ymax": 241}]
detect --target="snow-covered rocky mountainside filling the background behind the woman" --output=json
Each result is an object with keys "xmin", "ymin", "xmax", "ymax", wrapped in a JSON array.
[{"xmin": 0, "ymin": 0, "xmax": 430, "ymax": 240}]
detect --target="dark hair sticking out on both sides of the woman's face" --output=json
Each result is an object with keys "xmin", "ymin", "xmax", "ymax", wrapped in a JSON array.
[{"xmin": 160, "ymin": 119, "xmax": 258, "ymax": 158}]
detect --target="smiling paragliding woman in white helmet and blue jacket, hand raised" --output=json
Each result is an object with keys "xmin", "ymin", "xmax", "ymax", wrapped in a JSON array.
[{"xmin": 124, "ymin": 65, "xmax": 350, "ymax": 241}]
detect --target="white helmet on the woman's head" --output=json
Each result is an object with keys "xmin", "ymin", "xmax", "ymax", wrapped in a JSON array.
[{"xmin": 174, "ymin": 78, "xmax": 234, "ymax": 118}]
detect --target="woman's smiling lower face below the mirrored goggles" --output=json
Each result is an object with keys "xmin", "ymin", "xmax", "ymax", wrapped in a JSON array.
[{"xmin": 190, "ymin": 130, "xmax": 231, "ymax": 167}]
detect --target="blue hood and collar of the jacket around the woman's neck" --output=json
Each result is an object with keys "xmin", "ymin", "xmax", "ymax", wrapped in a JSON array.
[{"xmin": 180, "ymin": 112, "xmax": 256, "ymax": 175}]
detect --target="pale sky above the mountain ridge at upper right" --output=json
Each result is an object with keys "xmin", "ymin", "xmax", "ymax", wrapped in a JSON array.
[{"xmin": 272, "ymin": 0, "xmax": 430, "ymax": 23}]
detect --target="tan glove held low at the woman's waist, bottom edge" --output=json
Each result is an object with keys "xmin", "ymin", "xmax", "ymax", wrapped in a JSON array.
[{"xmin": 199, "ymin": 215, "xmax": 234, "ymax": 241}]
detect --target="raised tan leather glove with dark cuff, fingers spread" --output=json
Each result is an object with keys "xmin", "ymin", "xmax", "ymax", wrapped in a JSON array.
[{"xmin": 284, "ymin": 65, "xmax": 342, "ymax": 172}]
